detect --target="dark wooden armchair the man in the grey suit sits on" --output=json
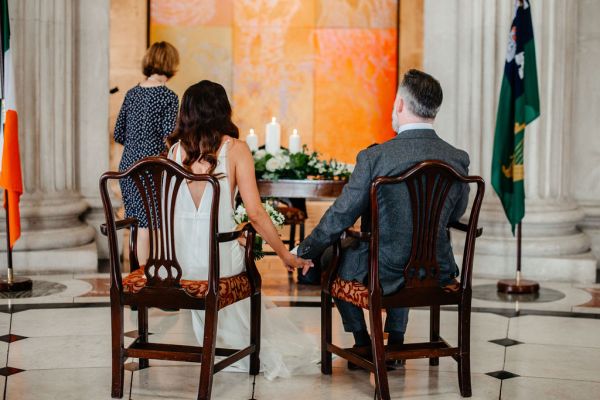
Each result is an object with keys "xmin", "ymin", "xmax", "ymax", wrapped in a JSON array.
[{"xmin": 321, "ymin": 160, "xmax": 485, "ymax": 400}]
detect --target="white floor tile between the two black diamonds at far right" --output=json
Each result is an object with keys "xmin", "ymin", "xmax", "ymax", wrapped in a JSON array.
[{"xmin": 504, "ymin": 344, "xmax": 600, "ymax": 382}]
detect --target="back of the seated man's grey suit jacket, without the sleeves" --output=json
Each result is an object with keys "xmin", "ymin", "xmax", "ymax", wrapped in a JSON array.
[{"xmin": 366, "ymin": 129, "xmax": 469, "ymax": 293}]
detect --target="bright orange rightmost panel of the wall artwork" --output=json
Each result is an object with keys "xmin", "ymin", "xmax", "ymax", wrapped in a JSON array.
[{"xmin": 314, "ymin": 29, "xmax": 397, "ymax": 162}]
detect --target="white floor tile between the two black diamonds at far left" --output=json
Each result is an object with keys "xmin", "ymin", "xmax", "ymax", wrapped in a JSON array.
[{"xmin": 8, "ymin": 335, "xmax": 111, "ymax": 370}]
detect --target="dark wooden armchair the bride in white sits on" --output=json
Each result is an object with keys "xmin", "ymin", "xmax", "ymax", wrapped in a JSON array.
[{"xmin": 100, "ymin": 157, "xmax": 261, "ymax": 400}]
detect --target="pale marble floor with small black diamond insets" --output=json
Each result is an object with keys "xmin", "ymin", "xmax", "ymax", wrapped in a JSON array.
[{"xmin": 0, "ymin": 257, "xmax": 600, "ymax": 400}]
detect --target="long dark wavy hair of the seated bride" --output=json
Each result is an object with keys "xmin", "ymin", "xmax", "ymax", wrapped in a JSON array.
[{"xmin": 167, "ymin": 80, "xmax": 240, "ymax": 174}]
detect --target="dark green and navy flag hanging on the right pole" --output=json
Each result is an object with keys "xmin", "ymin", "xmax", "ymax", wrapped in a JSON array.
[{"xmin": 492, "ymin": 0, "xmax": 540, "ymax": 234}]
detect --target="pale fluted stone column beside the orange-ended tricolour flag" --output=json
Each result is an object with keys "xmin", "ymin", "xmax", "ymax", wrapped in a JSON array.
[{"xmin": 0, "ymin": 0, "xmax": 98, "ymax": 272}]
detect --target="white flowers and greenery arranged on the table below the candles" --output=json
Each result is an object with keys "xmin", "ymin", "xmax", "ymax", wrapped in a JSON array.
[{"xmin": 253, "ymin": 145, "xmax": 354, "ymax": 180}]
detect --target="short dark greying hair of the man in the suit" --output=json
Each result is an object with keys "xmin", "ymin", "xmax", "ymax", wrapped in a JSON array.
[{"xmin": 398, "ymin": 69, "xmax": 444, "ymax": 119}]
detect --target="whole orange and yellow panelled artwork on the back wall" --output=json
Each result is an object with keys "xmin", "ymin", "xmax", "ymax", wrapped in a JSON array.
[{"xmin": 150, "ymin": 0, "xmax": 398, "ymax": 162}]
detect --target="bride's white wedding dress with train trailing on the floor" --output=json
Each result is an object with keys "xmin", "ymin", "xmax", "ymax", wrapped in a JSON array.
[{"xmin": 169, "ymin": 140, "xmax": 319, "ymax": 379}]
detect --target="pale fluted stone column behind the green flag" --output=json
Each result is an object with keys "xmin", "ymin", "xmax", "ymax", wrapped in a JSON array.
[{"xmin": 424, "ymin": 0, "xmax": 596, "ymax": 283}]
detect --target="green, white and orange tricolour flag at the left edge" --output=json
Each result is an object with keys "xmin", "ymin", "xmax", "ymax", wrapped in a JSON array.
[{"xmin": 0, "ymin": 0, "xmax": 23, "ymax": 248}]
